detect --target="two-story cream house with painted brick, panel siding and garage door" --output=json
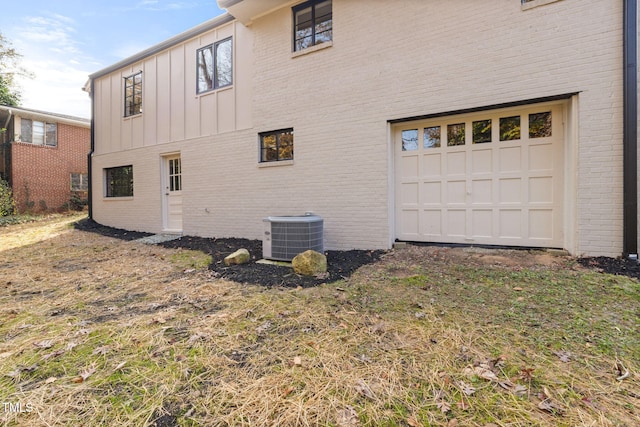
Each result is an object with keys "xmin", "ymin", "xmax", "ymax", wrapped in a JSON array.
[{"xmin": 87, "ymin": 0, "xmax": 638, "ymax": 256}]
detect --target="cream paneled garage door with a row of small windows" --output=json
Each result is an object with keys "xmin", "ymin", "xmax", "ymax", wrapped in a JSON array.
[{"xmin": 393, "ymin": 104, "xmax": 564, "ymax": 247}]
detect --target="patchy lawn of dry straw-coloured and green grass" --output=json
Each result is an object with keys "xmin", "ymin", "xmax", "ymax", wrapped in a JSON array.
[{"xmin": 0, "ymin": 216, "xmax": 640, "ymax": 427}]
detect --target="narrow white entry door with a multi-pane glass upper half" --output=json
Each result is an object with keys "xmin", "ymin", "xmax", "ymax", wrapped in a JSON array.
[{"xmin": 163, "ymin": 154, "xmax": 182, "ymax": 232}]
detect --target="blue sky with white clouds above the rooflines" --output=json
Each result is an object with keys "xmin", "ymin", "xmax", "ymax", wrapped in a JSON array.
[{"xmin": 0, "ymin": 0, "xmax": 223, "ymax": 118}]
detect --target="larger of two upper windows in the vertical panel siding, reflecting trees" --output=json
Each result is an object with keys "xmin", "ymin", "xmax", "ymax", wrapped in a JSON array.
[{"xmin": 197, "ymin": 38, "xmax": 233, "ymax": 93}]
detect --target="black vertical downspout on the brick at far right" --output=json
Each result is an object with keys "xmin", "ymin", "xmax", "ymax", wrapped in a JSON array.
[{"xmin": 622, "ymin": 0, "xmax": 638, "ymax": 260}]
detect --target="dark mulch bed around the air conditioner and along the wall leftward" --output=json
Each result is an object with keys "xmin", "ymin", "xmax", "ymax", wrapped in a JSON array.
[{"xmin": 75, "ymin": 219, "xmax": 385, "ymax": 287}]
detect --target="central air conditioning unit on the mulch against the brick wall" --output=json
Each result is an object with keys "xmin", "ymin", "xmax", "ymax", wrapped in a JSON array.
[{"xmin": 262, "ymin": 213, "xmax": 324, "ymax": 261}]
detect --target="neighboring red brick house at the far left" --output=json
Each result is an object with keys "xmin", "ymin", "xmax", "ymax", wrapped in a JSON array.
[{"xmin": 0, "ymin": 106, "xmax": 91, "ymax": 212}]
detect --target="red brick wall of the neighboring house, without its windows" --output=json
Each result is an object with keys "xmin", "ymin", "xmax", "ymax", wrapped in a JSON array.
[{"xmin": 11, "ymin": 123, "xmax": 91, "ymax": 212}]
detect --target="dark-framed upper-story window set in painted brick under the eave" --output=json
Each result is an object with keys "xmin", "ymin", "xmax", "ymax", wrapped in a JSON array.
[{"xmin": 293, "ymin": 0, "xmax": 333, "ymax": 51}]
